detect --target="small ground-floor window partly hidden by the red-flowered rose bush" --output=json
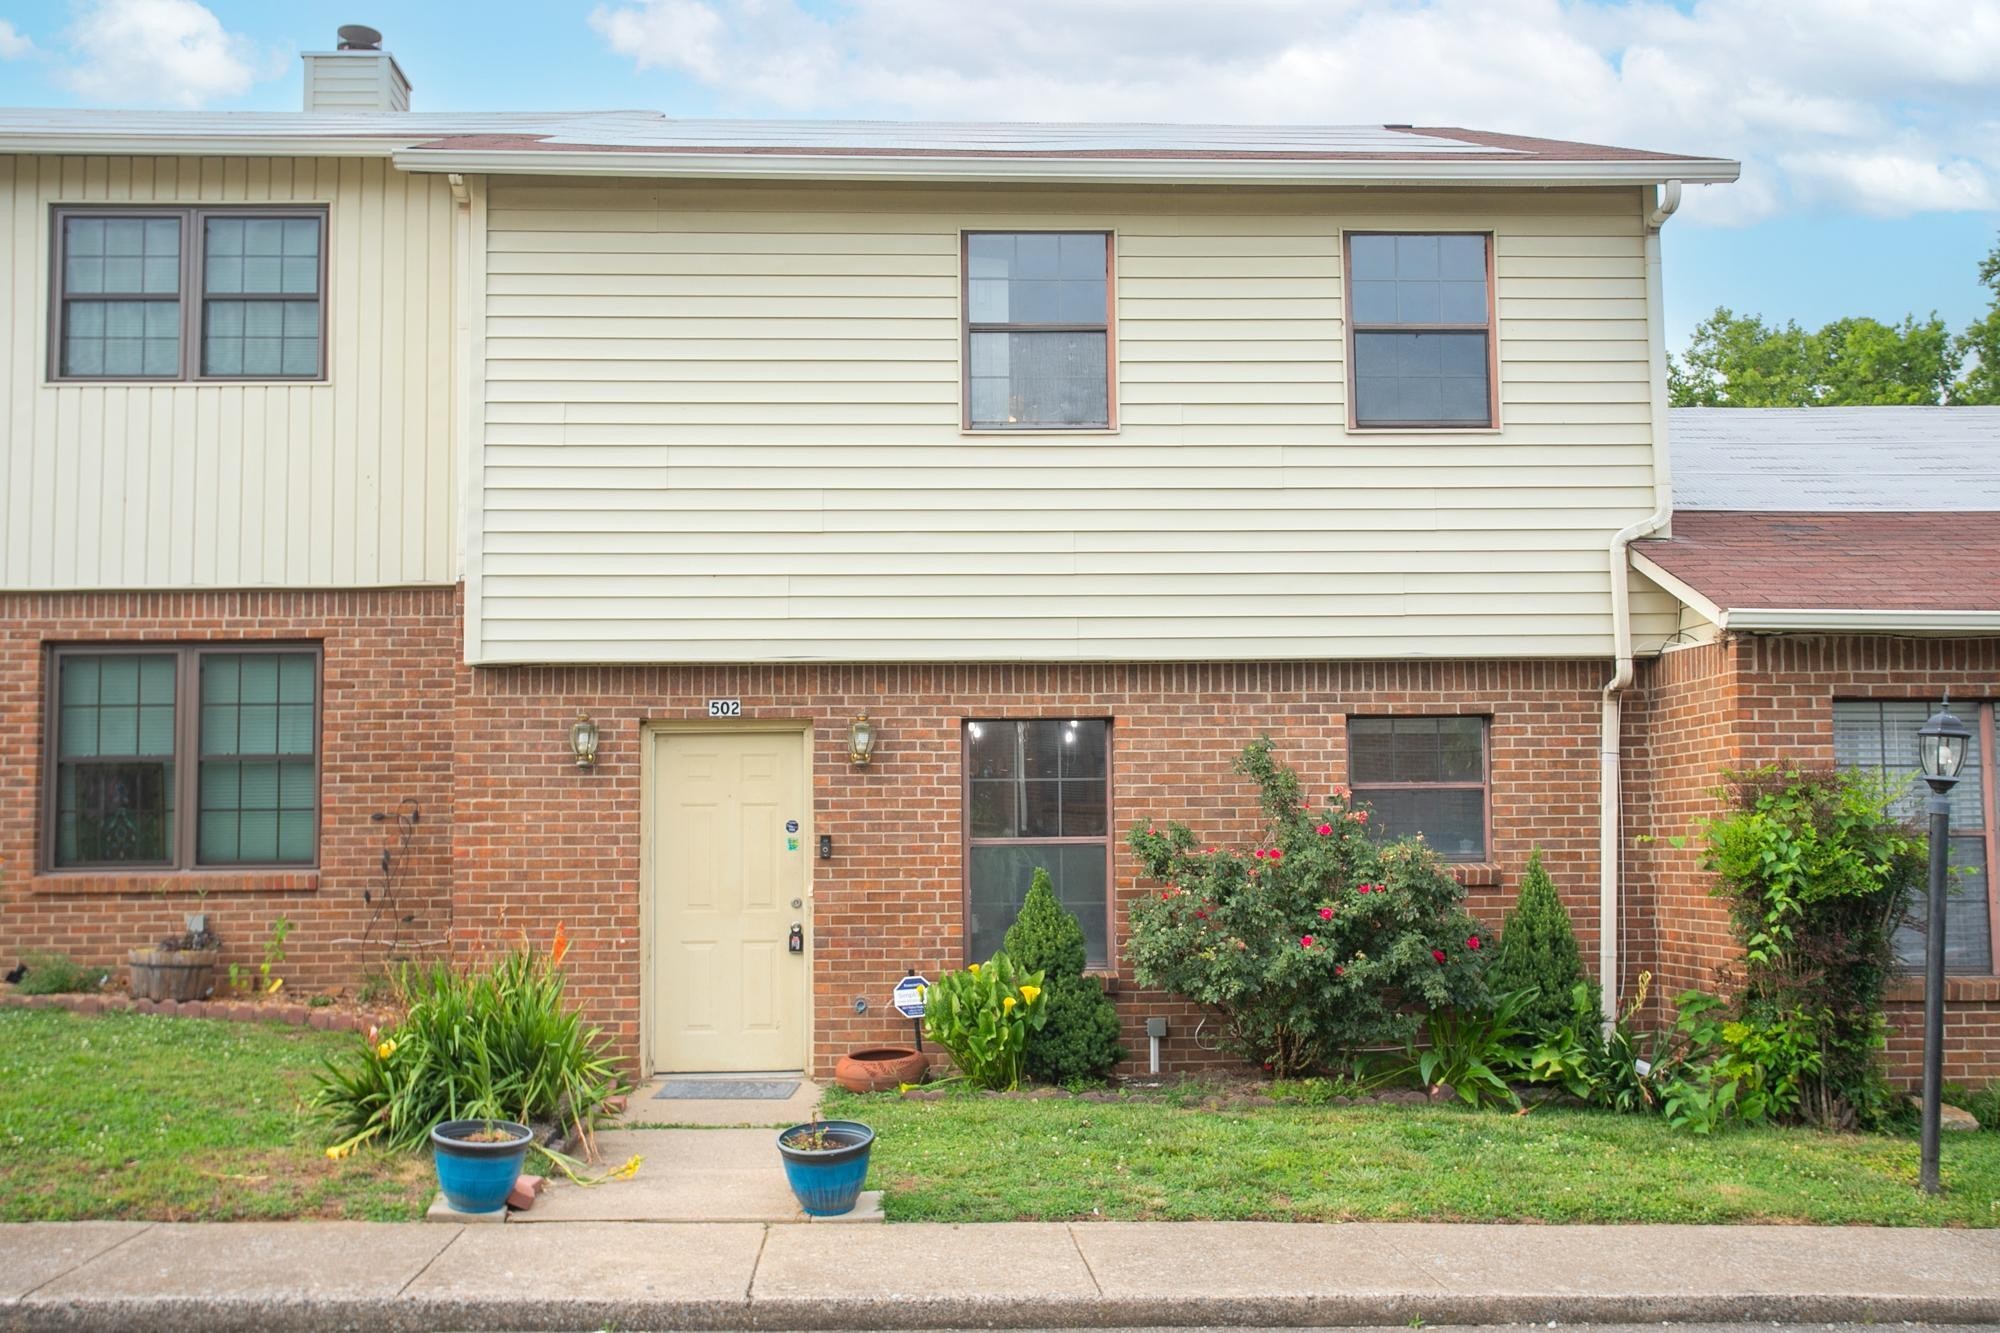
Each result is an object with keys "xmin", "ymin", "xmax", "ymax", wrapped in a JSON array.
[{"xmin": 1348, "ymin": 717, "xmax": 1490, "ymax": 861}]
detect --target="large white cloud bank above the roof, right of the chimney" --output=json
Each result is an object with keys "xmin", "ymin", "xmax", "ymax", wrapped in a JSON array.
[{"xmin": 590, "ymin": 0, "xmax": 2000, "ymax": 222}]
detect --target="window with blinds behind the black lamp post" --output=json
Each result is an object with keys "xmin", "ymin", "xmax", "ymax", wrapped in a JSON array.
[{"xmin": 1834, "ymin": 699, "xmax": 2000, "ymax": 977}]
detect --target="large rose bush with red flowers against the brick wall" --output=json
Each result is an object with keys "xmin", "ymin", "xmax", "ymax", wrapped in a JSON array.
[{"xmin": 1126, "ymin": 739, "xmax": 1486, "ymax": 1079}]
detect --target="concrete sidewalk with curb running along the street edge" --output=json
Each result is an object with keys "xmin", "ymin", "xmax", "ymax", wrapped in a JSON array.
[{"xmin": 0, "ymin": 1223, "xmax": 2000, "ymax": 1333}]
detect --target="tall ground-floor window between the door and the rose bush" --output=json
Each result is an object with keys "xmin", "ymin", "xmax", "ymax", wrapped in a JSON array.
[{"xmin": 964, "ymin": 719, "xmax": 1112, "ymax": 967}]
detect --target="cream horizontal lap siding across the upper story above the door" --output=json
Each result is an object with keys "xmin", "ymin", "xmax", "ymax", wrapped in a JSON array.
[{"xmin": 468, "ymin": 178, "xmax": 1660, "ymax": 662}]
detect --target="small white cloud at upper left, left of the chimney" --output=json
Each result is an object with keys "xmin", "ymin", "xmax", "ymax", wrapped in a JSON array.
[{"xmin": 60, "ymin": 0, "xmax": 284, "ymax": 108}]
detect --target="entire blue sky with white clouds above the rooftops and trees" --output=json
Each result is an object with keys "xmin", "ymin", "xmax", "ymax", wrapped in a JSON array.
[{"xmin": 0, "ymin": 0, "xmax": 2000, "ymax": 346}]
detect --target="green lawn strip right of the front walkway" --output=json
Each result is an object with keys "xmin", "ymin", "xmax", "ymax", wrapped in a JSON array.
[{"xmin": 824, "ymin": 1091, "xmax": 2000, "ymax": 1227}]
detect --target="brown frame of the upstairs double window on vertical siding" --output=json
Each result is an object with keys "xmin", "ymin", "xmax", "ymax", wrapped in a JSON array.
[{"xmin": 46, "ymin": 204, "xmax": 332, "ymax": 384}]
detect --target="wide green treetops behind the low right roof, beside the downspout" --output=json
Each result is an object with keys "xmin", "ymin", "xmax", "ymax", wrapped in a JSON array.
[{"xmin": 1666, "ymin": 306, "xmax": 1964, "ymax": 406}]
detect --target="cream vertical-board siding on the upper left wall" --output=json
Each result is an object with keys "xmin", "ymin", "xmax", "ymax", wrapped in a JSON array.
[{"xmin": 0, "ymin": 156, "xmax": 458, "ymax": 588}]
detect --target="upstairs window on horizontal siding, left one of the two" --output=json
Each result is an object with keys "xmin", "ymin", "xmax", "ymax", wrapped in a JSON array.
[{"xmin": 962, "ymin": 232, "xmax": 1116, "ymax": 430}]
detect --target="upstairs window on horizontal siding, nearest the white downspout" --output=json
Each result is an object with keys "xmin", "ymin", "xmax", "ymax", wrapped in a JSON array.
[{"xmin": 1346, "ymin": 232, "xmax": 1494, "ymax": 430}]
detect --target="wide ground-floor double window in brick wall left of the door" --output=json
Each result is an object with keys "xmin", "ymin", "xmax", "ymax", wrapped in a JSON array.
[{"xmin": 44, "ymin": 644, "xmax": 320, "ymax": 871}]
